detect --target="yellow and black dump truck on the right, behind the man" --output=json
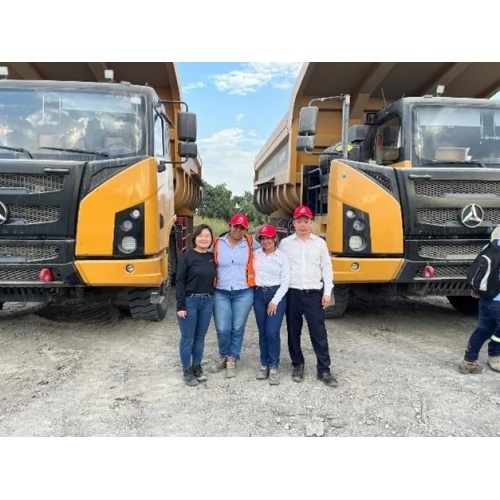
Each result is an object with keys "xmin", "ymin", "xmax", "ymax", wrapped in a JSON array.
[{"xmin": 254, "ymin": 62, "xmax": 500, "ymax": 317}]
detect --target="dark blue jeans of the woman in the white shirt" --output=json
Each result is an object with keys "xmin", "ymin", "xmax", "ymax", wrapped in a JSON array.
[{"xmin": 253, "ymin": 286, "xmax": 286, "ymax": 370}]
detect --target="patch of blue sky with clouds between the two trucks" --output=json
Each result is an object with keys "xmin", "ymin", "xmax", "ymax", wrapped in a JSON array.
[{"xmin": 177, "ymin": 62, "xmax": 302, "ymax": 195}]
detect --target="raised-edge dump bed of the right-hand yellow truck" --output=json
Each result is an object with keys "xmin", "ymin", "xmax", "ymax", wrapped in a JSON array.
[{"xmin": 254, "ymin": 62, "xmax": 500, "ymax": 217}]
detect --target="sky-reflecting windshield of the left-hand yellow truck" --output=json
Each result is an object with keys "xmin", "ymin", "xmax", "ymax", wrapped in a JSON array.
[{"xmin": 0, "ymin": 89, "xmax": 146, "ymax": 158}]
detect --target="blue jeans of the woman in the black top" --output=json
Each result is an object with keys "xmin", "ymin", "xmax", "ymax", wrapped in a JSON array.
[{"xmin": 177, "ymin": 293, "xmax": 214, "ymax": 370}]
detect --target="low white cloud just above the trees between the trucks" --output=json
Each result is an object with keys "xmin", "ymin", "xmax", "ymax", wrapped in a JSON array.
[{"xmin": 198, "ymin": 127, "xmax": 264, "ymax": 196}]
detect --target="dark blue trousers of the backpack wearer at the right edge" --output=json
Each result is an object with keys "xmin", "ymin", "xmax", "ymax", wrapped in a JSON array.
[{"xmin": 465, "ymin": 299, "xmax": 500, "ymax": 361}]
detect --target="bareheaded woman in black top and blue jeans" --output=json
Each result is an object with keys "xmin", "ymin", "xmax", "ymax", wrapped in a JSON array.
[{"xmin": 175, "ymin": 224, "xmax": 216, "ymax": 385}]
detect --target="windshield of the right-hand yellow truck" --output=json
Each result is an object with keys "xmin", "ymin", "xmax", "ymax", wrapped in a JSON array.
[{"xmin": 413, "ymin": 105, "xmax": 500, "ymax": 167}]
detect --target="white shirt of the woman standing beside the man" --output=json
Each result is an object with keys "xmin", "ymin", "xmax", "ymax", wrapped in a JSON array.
[{"xmin": 253, "ymin": 248, "xmax": 290, "ymax": 305}]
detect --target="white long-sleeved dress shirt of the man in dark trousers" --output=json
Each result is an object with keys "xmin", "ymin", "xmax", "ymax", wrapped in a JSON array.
[{"xmin": 279, "ymin": 233, "xmax": 333, "ymax": 295}]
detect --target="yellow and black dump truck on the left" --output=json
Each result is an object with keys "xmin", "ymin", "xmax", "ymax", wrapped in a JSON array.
[{"xmin": 0, "ymin": 62, "xmax": 201, "ymax": 321}]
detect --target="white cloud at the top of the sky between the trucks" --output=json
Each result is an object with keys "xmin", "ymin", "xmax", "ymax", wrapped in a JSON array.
[{"xmin": 211, "ymin": 62, "xmax": 302, "ymax": 95}]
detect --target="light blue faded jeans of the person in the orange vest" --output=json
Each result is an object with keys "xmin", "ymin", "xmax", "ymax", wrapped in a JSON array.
[{"xmin": 214, "ymin": 288, "xmax": 253, "ymax": 360}]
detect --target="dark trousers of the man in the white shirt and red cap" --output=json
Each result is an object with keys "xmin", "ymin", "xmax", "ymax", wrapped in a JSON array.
[{"xmin": 286, "ymin": 288, "xmax": 330, "ymax": 373}]
